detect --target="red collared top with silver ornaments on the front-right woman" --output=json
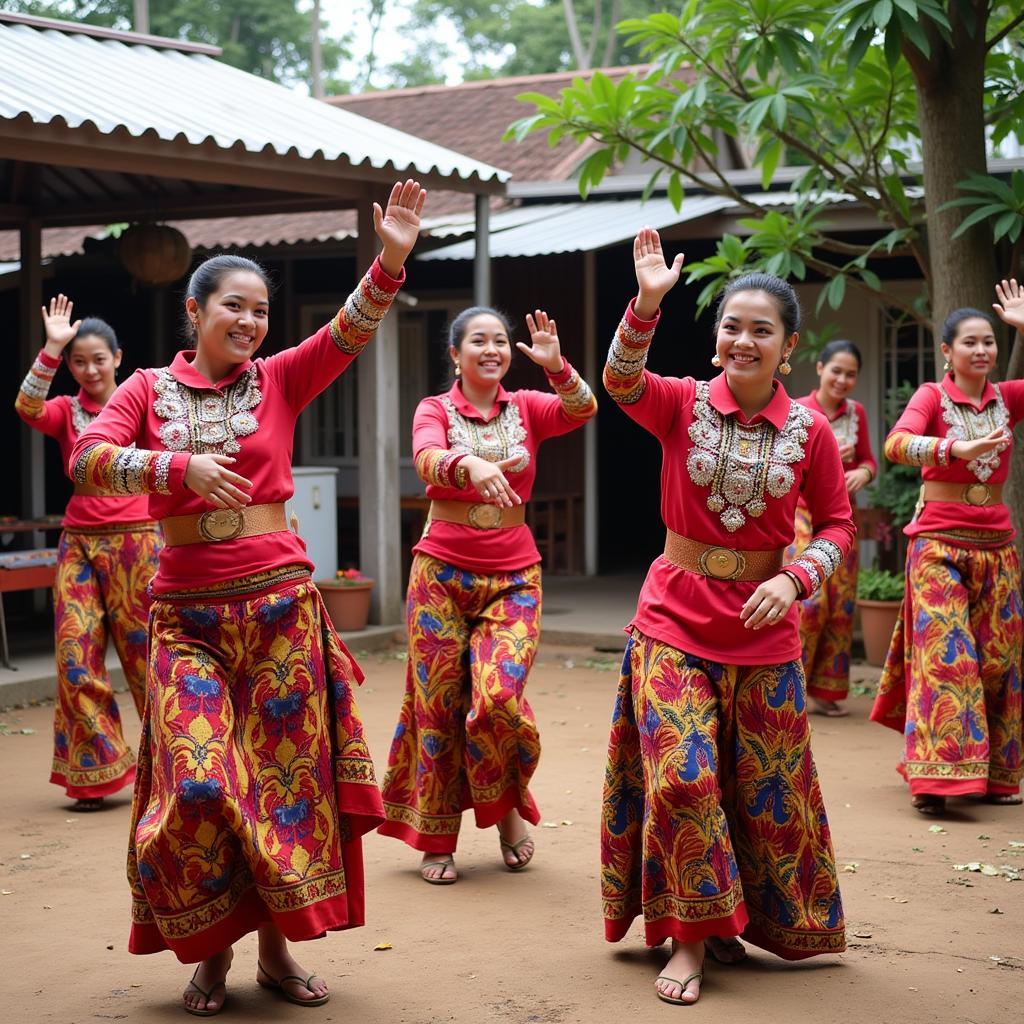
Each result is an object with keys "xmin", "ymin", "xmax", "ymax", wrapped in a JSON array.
[{"xmin": 604, "ymin": 302, "xmax": 854, "ymax": 665}]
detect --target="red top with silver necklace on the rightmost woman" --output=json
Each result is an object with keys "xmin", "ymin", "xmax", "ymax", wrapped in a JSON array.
[{"xmin": 886, "ymin": 374, "xmax": 1024, "ymax": 542}]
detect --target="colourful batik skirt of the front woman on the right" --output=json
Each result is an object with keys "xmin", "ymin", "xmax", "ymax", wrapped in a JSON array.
[{"xmin": 601, "ymin": 630, "xmax": 846, "ymax": 959}]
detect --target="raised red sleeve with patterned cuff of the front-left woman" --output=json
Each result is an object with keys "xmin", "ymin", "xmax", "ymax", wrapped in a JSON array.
[{"xmin": 263, "ymin": 259, "xmax": 406, "ymax": 414}]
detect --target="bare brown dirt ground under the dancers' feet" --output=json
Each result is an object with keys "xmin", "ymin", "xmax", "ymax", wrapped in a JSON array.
[{"xmin": 0, "ymin": 648, "xmax": 1024, "ymax": 1024}]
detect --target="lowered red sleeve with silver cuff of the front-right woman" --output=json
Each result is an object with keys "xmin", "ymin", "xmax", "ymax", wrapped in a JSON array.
[{"xmin": 784, "ymin": 417, "xmax": 856, "ymax": 597}]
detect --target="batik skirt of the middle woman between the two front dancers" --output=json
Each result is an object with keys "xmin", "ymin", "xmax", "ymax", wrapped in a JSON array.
[{"xmin": 380, "ymin": 554, "xmax": 541, "ymax": 853}]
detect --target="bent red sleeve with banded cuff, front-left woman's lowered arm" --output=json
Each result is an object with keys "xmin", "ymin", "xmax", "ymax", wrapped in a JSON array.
[{"xmin": 68, "ymin": 370, "xmax": 191, "ymax": 495}]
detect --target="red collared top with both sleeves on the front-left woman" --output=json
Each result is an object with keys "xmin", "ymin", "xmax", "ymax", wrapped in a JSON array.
[{"xmin": 71, "ymin": 261, "xmax": 400, "ymax": 595}]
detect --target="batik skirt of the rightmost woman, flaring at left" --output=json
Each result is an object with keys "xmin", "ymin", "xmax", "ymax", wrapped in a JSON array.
[{"xmin": 871, "ymin": 537, "xmax": 1024, "ymax": 797}]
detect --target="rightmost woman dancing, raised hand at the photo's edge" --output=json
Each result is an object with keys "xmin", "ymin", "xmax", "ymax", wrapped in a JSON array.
[{"xmin": 871, "ymin": 281, "xmax": 1024, "ymax": 814}]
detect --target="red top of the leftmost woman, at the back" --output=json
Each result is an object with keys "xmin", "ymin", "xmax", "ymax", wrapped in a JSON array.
[{"xmin": 14, "ymin": 349, "xmax": 151, "ymax": 529}]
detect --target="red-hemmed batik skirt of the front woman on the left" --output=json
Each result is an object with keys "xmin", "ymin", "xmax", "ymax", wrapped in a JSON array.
[{"xmin": 128, "ymin": 566, "xmax": 384, "ymax": 963}]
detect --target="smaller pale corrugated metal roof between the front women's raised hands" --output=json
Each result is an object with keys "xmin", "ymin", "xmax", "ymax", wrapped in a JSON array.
[{"xmin": 417, "ymin": 196, "xmax": 732, "ymax": 260}]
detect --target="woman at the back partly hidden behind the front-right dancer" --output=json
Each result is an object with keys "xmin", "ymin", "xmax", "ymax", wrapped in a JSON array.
[{"xmin": 786, "ymin": 339, "xmax": 878, "ymax": 718}]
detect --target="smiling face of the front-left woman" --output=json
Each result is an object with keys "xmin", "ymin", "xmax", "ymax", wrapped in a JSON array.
[{"xmin": 185, "ymin": 270, "xmax": 270, "ymax": 377}]
